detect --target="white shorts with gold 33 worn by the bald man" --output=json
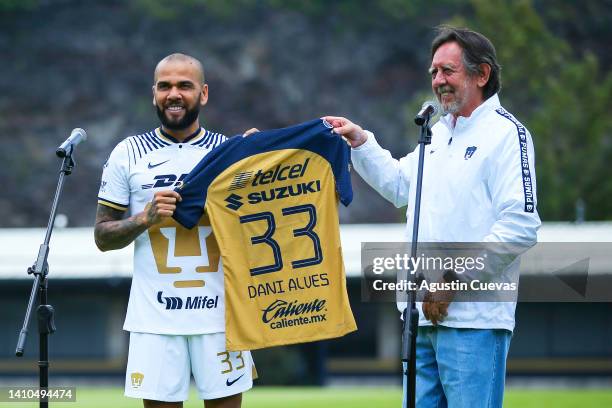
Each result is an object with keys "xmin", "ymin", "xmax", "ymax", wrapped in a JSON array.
[{"xmin": 125, "ymin": 333, "xmax": 256, "ymax": 402}]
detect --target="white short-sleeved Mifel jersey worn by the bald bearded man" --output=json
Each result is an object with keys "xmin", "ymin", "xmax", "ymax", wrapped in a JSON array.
[{"xmin": 98, "ymin": 128, "xmax": 226, "ymax": 335}]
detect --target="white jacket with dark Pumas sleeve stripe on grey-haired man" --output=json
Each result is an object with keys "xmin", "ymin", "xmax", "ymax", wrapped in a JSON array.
[{"xmin": 351, "ymin": 94, "xmax": 540, "ymax": 330}]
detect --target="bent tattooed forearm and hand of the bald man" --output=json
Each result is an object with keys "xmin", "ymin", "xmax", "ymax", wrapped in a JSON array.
[{"xmin": 94, "ymin": 190, "xmax": 181, "ymax": 251}]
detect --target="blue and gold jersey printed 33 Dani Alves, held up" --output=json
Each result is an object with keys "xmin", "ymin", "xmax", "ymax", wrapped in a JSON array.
[{"xmin": 174, "ymin": 119, "xmax": 356, "ymax": 350}]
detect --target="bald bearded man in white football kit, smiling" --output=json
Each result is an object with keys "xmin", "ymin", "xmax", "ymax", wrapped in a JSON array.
[{"xmin": 95, "ymin": 54, "xmax": 253, "ymax": 408}]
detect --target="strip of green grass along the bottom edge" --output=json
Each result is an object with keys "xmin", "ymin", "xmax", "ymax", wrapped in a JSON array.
[{"xmin": 10, "ymin": 387, "xmax": 612, "ymax": 408}]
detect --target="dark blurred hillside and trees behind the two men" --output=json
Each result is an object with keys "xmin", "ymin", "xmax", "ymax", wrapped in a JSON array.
[{"xmin": 0, "ymin": 0, "xmax": 612, "ymax": 227}]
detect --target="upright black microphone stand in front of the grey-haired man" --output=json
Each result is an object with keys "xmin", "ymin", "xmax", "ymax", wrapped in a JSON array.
[{"xmin": 402, "ymin": 113, "xmax": 431, "ymax": 408}]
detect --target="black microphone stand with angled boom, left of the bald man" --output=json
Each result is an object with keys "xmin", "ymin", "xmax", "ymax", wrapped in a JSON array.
[{"xmin": 15, "ymin": 146, "xmax": 75, "ymax": 408}]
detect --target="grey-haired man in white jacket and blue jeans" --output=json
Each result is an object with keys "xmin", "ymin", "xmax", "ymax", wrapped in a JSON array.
[{"xmin": 325, "ymin": 27, "xmax": 540, "ymax": 408}]
